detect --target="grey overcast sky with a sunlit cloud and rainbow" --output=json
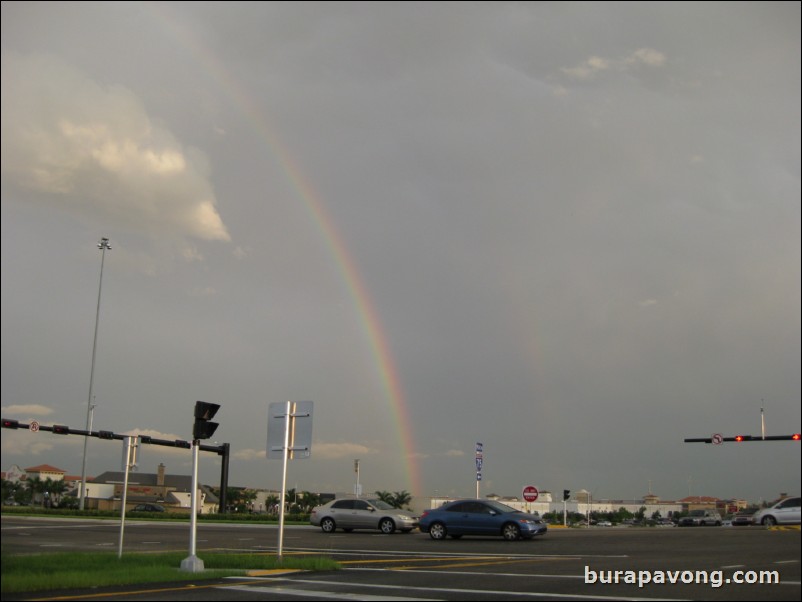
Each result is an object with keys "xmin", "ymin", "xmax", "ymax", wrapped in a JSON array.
[{"xmin": 2, "ymin": 2, "xmax": 801, "ymax": 501}]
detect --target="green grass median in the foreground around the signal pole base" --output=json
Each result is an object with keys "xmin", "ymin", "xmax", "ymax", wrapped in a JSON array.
[{"xmin": 0, "ymin": 552, "xmax": 340, "ymax": 593}]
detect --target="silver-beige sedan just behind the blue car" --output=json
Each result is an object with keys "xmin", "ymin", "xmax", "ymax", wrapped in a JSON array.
[{"xmin": 309, "ymin": 499, "xmax": 418, "ymax": 534}]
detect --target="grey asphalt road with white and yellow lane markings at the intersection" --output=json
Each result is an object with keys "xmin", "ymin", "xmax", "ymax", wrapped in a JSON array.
[{"xmin": 2, "ymin": 516, "xmax": 802, "ymax": 601}]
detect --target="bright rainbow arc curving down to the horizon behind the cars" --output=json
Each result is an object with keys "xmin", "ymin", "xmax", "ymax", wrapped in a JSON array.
[{"xmin": 148, "ymin": 2, "xmax": 423, "ymax": 495}]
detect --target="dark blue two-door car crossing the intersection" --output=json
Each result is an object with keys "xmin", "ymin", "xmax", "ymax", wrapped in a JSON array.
[{"xmin": 420, "ymin": 500, "xmax": 548, "ymax": 541}]
